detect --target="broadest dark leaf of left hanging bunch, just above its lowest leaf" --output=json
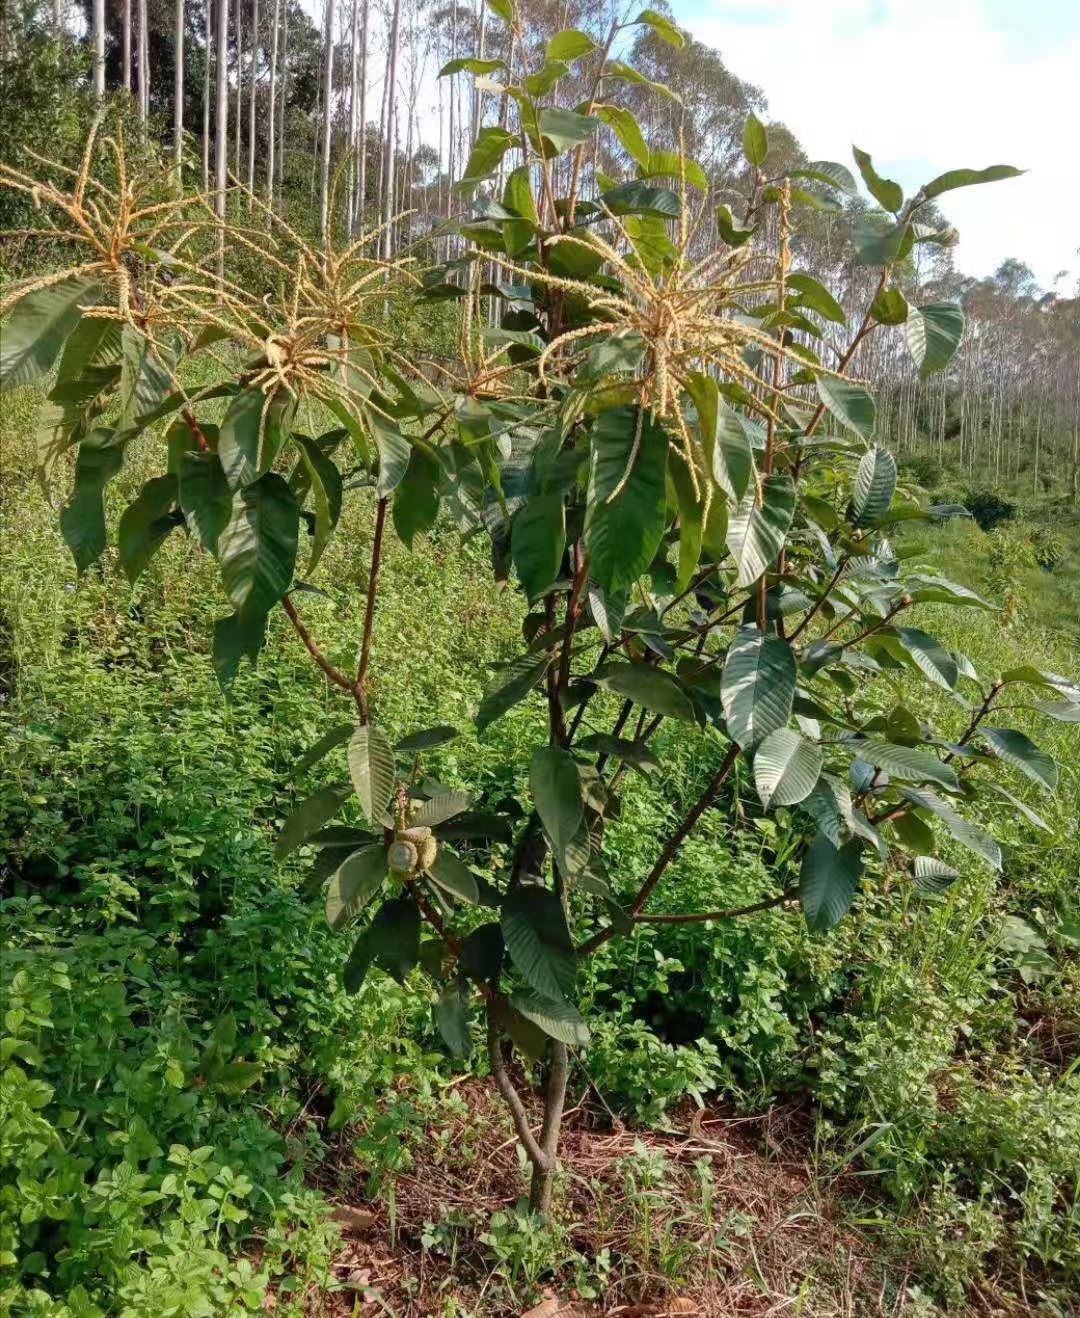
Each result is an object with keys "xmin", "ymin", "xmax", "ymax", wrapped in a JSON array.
[{"xmin": 218, "ymin": 472, "xmax": 299, "ymax": 617}]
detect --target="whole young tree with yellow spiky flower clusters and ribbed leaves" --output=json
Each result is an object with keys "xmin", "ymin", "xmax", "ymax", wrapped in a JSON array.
[{"xmin": 0, "ymin": 12, "xmax": 1080, "ymax": 1213}]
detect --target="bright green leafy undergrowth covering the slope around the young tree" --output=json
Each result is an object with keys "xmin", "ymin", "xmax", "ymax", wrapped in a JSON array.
[{"xmin": 0, "ymin": 394, "xmax": 1080, "ymax": 1318}]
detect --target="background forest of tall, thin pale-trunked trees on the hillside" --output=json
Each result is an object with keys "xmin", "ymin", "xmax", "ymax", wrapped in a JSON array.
[{"xmin": 0, "ymin": 0, "xmax": 1080, "ymax": 506}]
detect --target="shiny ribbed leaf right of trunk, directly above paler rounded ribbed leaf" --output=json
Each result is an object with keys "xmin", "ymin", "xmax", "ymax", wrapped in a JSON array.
[{"xmin": 720, "ymin": 626, "xmax": 796, "ymax": 753}]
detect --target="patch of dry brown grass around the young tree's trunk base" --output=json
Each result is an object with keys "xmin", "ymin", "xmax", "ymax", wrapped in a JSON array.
[{"xmin": 295, "ymin": 1081, "xmax": 910, "ymax": 1318}]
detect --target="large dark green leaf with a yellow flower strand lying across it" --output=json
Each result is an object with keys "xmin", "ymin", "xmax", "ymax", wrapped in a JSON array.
[{"xmin": 585, "ymin": 407, "xmax": 667, "ymax": 590}]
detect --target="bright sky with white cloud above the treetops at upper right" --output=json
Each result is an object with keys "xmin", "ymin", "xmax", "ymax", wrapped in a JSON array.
[{"xmin": 671, "ymin": 0, "xmax": 1080, "ymax": 294}]
